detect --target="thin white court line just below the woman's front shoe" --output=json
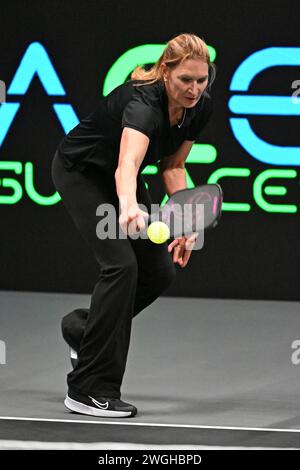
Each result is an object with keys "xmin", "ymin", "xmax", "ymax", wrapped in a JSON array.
[{"xmin": 0, "ymin": 416, "xmax": 300, "ymax": 433}]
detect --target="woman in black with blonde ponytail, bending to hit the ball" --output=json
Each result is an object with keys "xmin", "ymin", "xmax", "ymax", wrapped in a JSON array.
[{"xmin": 52, "ymin": 34, "xmax": 215, "ymax": 418}]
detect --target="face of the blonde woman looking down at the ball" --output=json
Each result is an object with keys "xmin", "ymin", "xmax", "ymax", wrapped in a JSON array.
[{"xmin": 162, "ymin": 59, "xmax": 208, "ymax": 108}]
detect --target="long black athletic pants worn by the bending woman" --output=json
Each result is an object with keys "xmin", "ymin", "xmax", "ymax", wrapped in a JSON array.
[{"xmin": 52, "ymin": 153, "xmax": 176, "ymax": 398}]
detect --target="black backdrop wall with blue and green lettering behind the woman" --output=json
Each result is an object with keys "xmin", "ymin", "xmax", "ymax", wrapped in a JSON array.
[{"xmin": 0, "ymin": 0, "xmax": 300, "ymax": 300}]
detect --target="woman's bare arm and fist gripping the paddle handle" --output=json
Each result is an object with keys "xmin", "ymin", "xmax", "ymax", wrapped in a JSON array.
[{"xmin": 115, "ymin": 127, "xmax": 149, "ymax": 233}]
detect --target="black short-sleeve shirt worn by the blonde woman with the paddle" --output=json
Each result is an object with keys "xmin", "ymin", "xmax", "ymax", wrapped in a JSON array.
[{"xmin": 58, "ymin": 80, "xmax": 212, "ymax": 174}]
